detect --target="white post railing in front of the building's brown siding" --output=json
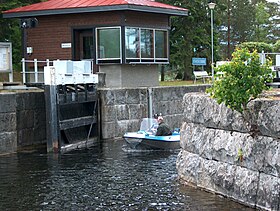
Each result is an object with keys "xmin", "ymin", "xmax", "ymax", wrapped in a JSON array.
[{"xmin": 21, "ymin": 58, "xmax": 53, "ymax": 84}]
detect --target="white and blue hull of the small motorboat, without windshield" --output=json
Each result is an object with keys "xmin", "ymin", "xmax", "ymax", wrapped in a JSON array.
[{"xmin": 123, "ymin": 132, "xmax": 180, "ymax": 150}]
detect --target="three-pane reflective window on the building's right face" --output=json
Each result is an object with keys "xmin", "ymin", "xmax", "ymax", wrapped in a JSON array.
[{"xmin": 125, "ymin": 27, "xmax": 168, "ymax": 63}]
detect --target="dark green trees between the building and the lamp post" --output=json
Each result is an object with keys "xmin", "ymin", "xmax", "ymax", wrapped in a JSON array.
[{"xmin": 160, "ymin": 0, "xmax": 217, "ymax": 80}]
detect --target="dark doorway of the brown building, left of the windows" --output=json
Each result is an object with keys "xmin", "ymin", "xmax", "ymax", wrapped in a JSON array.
[{"xmin": 74, "ymin": 29, "xmax": 94, "ymax": 60}]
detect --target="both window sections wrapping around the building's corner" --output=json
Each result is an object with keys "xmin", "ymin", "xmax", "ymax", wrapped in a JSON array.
[{"xmin": 94, "ymin": 27, "xmax": 168, "ymax": 64}]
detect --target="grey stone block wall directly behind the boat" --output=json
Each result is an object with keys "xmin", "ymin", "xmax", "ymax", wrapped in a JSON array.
[{"xmin": 99, "ymin": 85, "xmax": 208, "ymax": 139}]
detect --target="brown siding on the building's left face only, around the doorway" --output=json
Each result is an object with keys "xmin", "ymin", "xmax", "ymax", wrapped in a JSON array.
[{"xmin": 27, "ymin": 12, "xmax": 121, "ymax": 60}]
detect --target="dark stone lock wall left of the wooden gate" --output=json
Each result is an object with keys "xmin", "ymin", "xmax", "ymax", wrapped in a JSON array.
[{"xmin": 0, "ymin": 91, "xmax": 46, "ymax": 154}]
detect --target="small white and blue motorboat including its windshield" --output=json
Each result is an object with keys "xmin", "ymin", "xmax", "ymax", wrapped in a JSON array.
[{"xmin": 123, "ymin": 118, "xmax": 180, "ymax": 150}]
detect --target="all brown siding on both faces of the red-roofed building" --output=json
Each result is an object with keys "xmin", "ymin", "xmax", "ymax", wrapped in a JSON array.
[{"xmin": 27, "ymin": 11, "xmax": 169, "ymax": 60}]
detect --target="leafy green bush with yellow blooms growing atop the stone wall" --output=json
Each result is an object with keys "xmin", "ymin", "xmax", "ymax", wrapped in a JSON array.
[{"xmin": 207, "ymin": 49, "xmax": 273, "ymax": 113}]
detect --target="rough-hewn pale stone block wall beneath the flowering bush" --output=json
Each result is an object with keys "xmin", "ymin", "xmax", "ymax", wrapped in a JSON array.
[{"xmin": 177, "ymin": 93, "xmax": 280, "ymax": 210}]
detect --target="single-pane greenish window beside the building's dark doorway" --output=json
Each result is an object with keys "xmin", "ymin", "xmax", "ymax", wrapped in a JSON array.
[{"xmin": 96, "ymin": 27, "xmax": 121, "ymax": 64}]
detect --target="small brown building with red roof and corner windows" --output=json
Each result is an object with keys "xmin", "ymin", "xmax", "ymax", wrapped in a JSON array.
[{"xmin": 3, "ymin": 0, "xmax": 188, "ymax": 87}]
